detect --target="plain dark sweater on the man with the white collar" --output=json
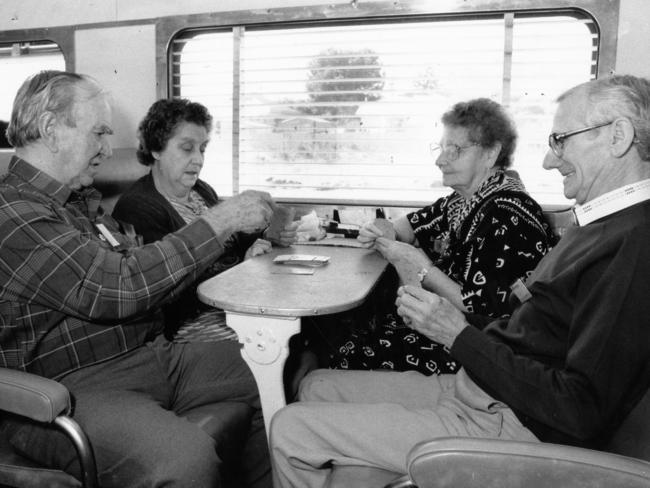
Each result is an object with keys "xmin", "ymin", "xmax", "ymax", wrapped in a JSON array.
[{"xmin": 451, "ymin": 201, "xmax": 650, "ymax": 447}]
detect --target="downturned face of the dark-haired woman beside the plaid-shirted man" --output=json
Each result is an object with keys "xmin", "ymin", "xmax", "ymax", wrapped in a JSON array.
[{"xmin": 153, "ymin": 122, "xmax": 210, "ymax": 197}]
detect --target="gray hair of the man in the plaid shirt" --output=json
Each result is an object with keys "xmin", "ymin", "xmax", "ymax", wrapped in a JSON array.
[{"xmin": 7, "ymin": 70, "xmax": 104, "ymax": 148}]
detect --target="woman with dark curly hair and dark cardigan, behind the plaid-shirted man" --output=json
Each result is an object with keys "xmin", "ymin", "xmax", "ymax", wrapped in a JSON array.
[{"xmin": 112, "ymin": 99, "xmax": 295, "ymax": 340}]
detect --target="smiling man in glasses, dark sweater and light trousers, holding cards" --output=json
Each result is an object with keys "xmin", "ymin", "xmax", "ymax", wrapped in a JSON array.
[{"xmin": 271, "ymin": 76, "xmax": 650, "ymax": 488}]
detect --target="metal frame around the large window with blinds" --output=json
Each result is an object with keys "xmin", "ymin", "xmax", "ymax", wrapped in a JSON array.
[{"xmin": 156, "ymin": 0, "xmax": 619, "ymax": 208}]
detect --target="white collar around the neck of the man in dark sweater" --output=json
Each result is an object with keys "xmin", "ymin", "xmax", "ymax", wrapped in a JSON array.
[{"xmin": 573, "ymin": 179, "xmax": 650, "ymax": 226}]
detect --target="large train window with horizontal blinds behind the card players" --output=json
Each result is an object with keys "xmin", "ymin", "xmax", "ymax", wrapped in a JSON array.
[{"xmin": 170, "ymin": 11, "xmax": 598, "ymax": 206}]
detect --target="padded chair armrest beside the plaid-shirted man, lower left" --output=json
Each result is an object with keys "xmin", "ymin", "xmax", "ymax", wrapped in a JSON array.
[{"xmin": 0, "ymin": 368, "xmax": 70, "ymax": 422}]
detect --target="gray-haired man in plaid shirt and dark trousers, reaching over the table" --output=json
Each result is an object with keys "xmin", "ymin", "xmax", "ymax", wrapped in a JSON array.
[{"xmin": 0, "ymin": 71, "xmax": 275, "ymax": 488}]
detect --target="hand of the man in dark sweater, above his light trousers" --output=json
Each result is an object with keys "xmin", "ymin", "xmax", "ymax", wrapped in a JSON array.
[{"xmin": 395, "ymin": 285, "xmax": 469, "ymax": 347}]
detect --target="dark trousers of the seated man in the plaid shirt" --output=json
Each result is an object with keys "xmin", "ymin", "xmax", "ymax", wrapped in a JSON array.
[{"xmin": 5, "ymin": 337, "xmax": 271, "ymax": 488}]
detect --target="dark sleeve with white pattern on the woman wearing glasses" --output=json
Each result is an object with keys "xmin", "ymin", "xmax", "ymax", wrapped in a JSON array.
[{"xmin": 452, "ymin": 195, "xmax": 552, "ymax": 316}]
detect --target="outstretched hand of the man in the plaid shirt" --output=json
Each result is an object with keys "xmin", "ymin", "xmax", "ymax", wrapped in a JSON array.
[{"xmin": 203, "ymin": 190, "xmax": 276, "ymax": 236}]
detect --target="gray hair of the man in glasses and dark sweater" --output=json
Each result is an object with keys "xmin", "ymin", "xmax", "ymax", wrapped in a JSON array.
[{"xmin": 558, "ymin": 75, "xmax": 650, "ymax": 161}]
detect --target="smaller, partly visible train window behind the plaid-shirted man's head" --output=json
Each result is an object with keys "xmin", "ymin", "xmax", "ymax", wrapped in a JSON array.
[{"xmin": 0, "ymin": 41, "xmax": 65, "ymax": 142}]
